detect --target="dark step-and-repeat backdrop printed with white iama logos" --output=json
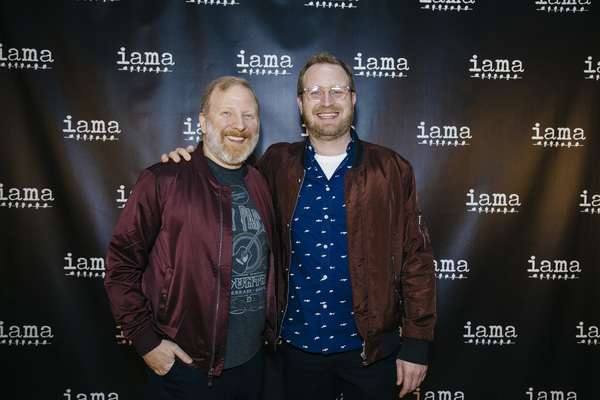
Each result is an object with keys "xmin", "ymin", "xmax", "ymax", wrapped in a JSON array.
[{"xmin": 0, "ymin": 0, "xmax": 600, "ymax": 400}]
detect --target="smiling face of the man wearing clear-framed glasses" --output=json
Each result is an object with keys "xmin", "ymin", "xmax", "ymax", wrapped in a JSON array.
[{"xmin": 297, "ymin": 63, "xmax": 356, "ymax": 141}]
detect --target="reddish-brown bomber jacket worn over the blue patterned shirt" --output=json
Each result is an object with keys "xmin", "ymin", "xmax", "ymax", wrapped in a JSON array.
[{"xmin": 256, "ymin": 132, "xmax": 437, "ymax": 365}]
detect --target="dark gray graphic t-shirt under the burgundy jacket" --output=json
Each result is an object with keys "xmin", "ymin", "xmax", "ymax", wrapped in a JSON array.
[{"xmin": 208, "ymin": 160, "xmax": 269, "ymax": 368}]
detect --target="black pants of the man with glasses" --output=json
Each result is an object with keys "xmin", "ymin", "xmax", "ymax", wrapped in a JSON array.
[{"xmin": 281, "ymin": 342, "xmax": 398, "ymax": 400}]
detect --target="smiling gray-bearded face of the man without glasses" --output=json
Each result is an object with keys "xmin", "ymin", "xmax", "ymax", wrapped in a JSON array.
[{"xmin": 200, "ymin": 85, "xmax": 259, "ymax": 169}]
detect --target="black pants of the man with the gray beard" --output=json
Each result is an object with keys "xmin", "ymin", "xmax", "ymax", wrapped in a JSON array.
[{"xmin": 147, "ymin": 348, "xmax": 263, "ymax": 400}]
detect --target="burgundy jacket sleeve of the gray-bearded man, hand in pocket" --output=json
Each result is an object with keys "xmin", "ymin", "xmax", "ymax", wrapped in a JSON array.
[{"xmin": 104, "ymin": 170, "xmax": 161, "ymax": 356}]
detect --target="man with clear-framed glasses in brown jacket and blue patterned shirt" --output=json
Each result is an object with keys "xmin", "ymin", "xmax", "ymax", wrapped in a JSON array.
[{"xmin": 163, "ymin": 53, "xmax": 436, "ymax": 400}]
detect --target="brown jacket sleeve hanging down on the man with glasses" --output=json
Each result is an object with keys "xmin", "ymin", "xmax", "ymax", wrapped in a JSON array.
[{"xmin": 398, "ymin": 163, "xmax": 437, "ymax": 365}]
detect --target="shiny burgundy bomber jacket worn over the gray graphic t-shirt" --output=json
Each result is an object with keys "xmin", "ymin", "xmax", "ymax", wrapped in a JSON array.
[{"xmin": 105, "ymin": 146, "xmax": 277, "ymax": 376}]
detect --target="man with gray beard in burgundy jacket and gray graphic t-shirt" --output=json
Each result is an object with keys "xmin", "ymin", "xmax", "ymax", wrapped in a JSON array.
[{"xmin": 105, "ymin": 77, "xmax": 276, "ymax": 400}]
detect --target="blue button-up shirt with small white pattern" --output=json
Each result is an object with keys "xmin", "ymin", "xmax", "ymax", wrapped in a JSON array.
[{"xmin": 282, "ymin": 137, "xmax": 362, "ymax": 354}]
